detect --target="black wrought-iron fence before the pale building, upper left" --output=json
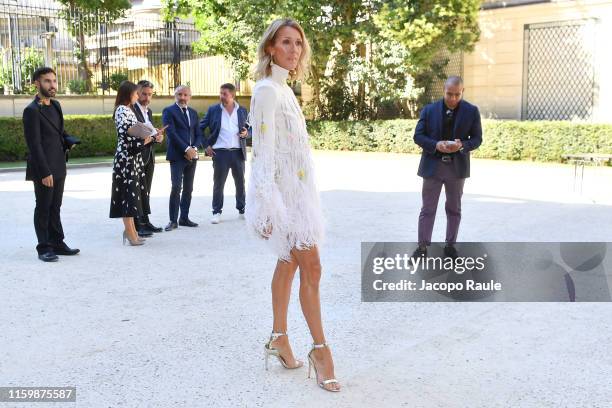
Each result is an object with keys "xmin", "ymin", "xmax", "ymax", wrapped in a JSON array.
[{"xmin": 0, "ymin": 0, "xmax": 249, "ymax": 95}]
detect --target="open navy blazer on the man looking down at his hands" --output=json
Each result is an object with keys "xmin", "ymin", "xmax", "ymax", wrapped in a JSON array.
[{"xmin": 414, "ymin": 99, "xmax": 482, "ymax": 178}]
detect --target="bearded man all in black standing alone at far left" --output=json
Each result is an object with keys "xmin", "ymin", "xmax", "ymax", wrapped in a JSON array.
[{"xmin": 23, "ymin": 67, "xmax": 79, "ymax": 262}]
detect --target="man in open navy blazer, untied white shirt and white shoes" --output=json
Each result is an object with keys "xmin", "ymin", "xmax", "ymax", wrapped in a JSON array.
[{"xmin": 200, "ymin": 84, "xmax": 248, "ymax": 224}]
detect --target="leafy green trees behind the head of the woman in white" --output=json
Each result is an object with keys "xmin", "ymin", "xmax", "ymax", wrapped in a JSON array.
[{"xmin": 163, "ymin": 0, "xmax": 480, "ymax": 120}]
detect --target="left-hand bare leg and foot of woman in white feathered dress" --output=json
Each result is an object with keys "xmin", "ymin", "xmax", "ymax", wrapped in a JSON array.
[{"xmin": 271, "ymin": 256, "xmax": 298, "ymax": 366}]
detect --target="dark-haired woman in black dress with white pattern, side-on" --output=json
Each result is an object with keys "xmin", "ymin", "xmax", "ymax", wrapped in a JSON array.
[{"xmin": 110, "ymin": 81, "xmax": 159, "ymax": 245}]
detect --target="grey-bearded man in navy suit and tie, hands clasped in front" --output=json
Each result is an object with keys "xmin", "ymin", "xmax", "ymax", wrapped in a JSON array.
[{"xmin": 162, "ymin": 85, "xmax": 202, "ymax": 231}]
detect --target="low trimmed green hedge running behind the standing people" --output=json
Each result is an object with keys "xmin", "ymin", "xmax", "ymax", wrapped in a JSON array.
[{"xmin": 0, "ymin": 114, "xmax": 612, "ymax": 161}]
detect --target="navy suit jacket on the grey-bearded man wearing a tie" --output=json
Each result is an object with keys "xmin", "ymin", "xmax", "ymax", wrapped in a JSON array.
[{"xmin": 162, "ymin": 103, "xmax": 204, "ymax": 161}]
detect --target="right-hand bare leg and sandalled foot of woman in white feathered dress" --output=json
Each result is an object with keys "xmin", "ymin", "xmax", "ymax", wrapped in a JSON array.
[{"xmin": 291, "ymin": 246, "xmax": 340, "ymax": 389}]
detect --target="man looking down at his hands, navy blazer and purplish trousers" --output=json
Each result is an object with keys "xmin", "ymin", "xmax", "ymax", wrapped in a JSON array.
[{"xmin": 413, "ymin": 76, "xmax": 482, "ymax": 257}]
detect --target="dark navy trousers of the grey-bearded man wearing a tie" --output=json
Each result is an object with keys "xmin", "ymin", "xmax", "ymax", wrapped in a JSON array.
[{"xmin": 169, "ymin": 160, "xmax": 198, "ymax": 222}]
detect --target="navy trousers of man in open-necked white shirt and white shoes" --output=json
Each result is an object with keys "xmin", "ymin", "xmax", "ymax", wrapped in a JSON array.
[{"xmin": 213, "ymin": 149, "xmax": 246, "ymax": 214}]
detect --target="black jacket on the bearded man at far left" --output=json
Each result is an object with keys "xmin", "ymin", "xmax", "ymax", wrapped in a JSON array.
[{"xmin": 23, "ymin": 95, "xmax": 70, "ymax": 181}]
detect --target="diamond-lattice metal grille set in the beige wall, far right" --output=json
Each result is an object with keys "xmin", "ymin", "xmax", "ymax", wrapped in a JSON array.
[{"xmin": 522, "ymin": 19, "xmax": 598, "ymax": 120}]
